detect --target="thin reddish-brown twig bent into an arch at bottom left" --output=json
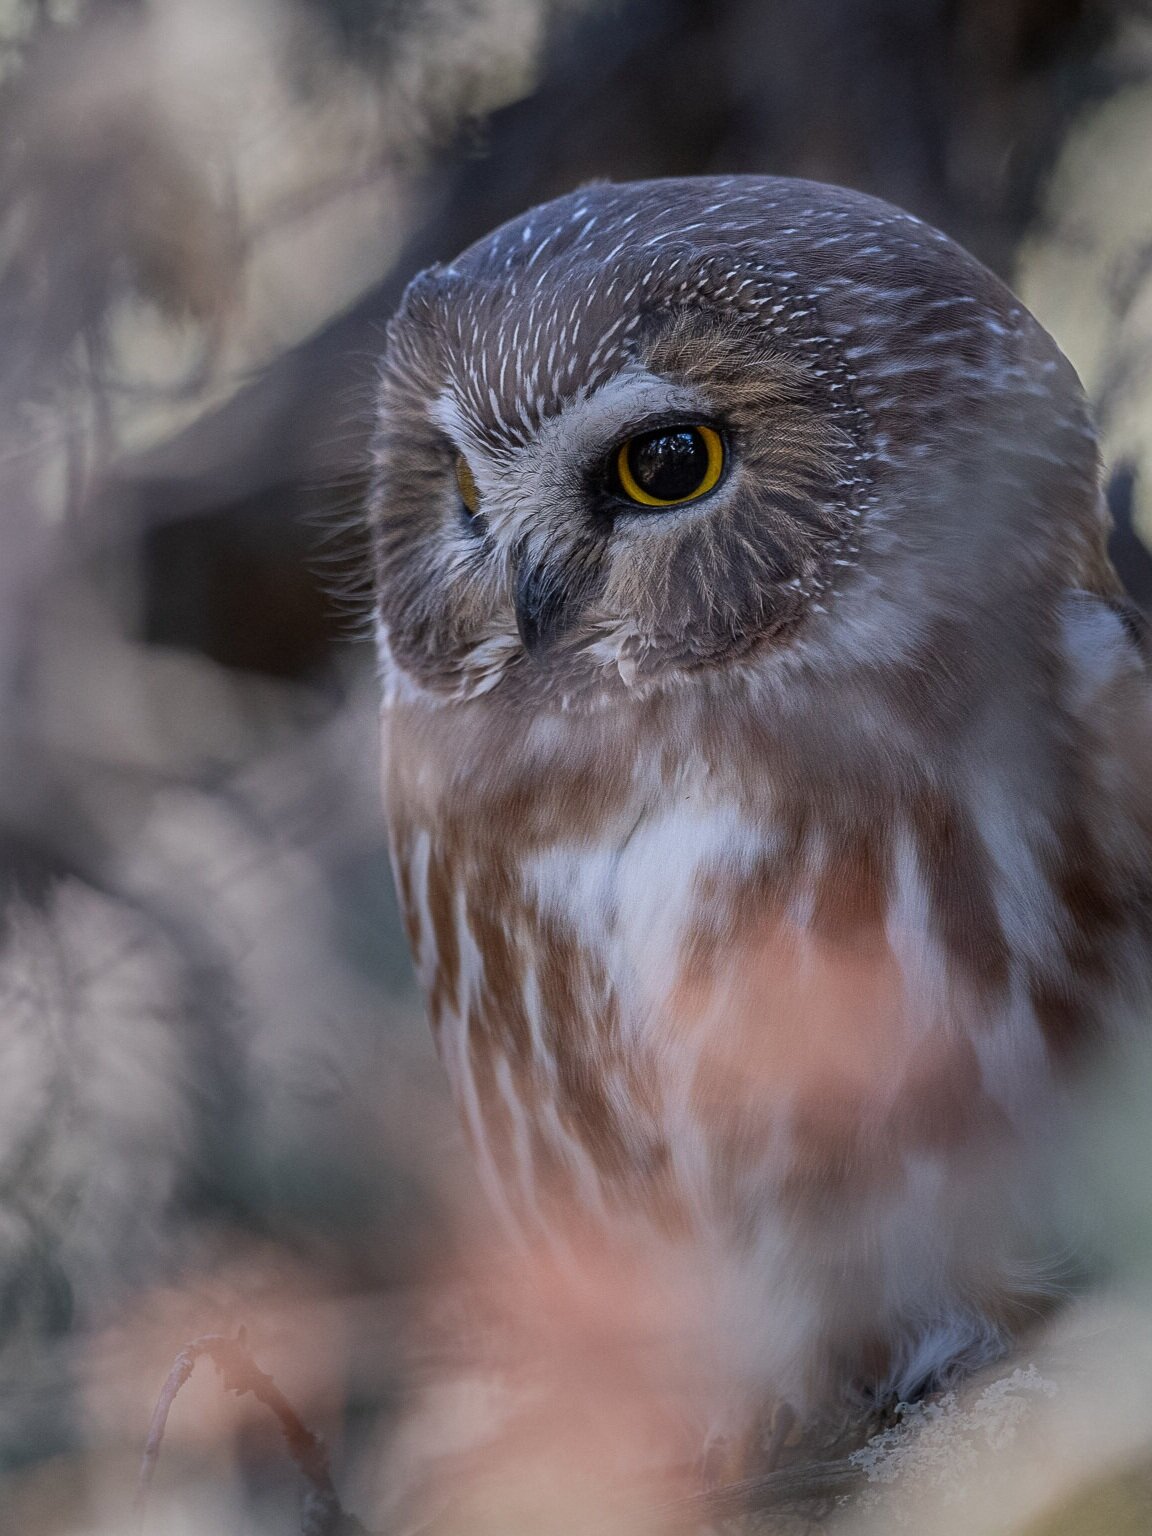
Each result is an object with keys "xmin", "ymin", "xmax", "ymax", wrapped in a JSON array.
[{"xmin": 132, "ymin": 1329, "xmax": 367, "ymax": 1536}]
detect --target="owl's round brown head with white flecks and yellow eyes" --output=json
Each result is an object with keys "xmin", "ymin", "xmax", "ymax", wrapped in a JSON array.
[{"xmin": 370, "ymin": 177, "xmax": 1104, "ymax": 708}]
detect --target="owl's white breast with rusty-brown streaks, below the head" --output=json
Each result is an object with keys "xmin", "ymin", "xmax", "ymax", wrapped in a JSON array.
[{"xmin": 395, "ymin": 724, "xmax": 1081, "ymax": 1402}]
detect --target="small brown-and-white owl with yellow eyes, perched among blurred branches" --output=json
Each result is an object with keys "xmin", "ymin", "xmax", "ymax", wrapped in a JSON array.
[{"xmin": 370, "ymin": 177, "xmax": 1152, "ymax": 1449}]
